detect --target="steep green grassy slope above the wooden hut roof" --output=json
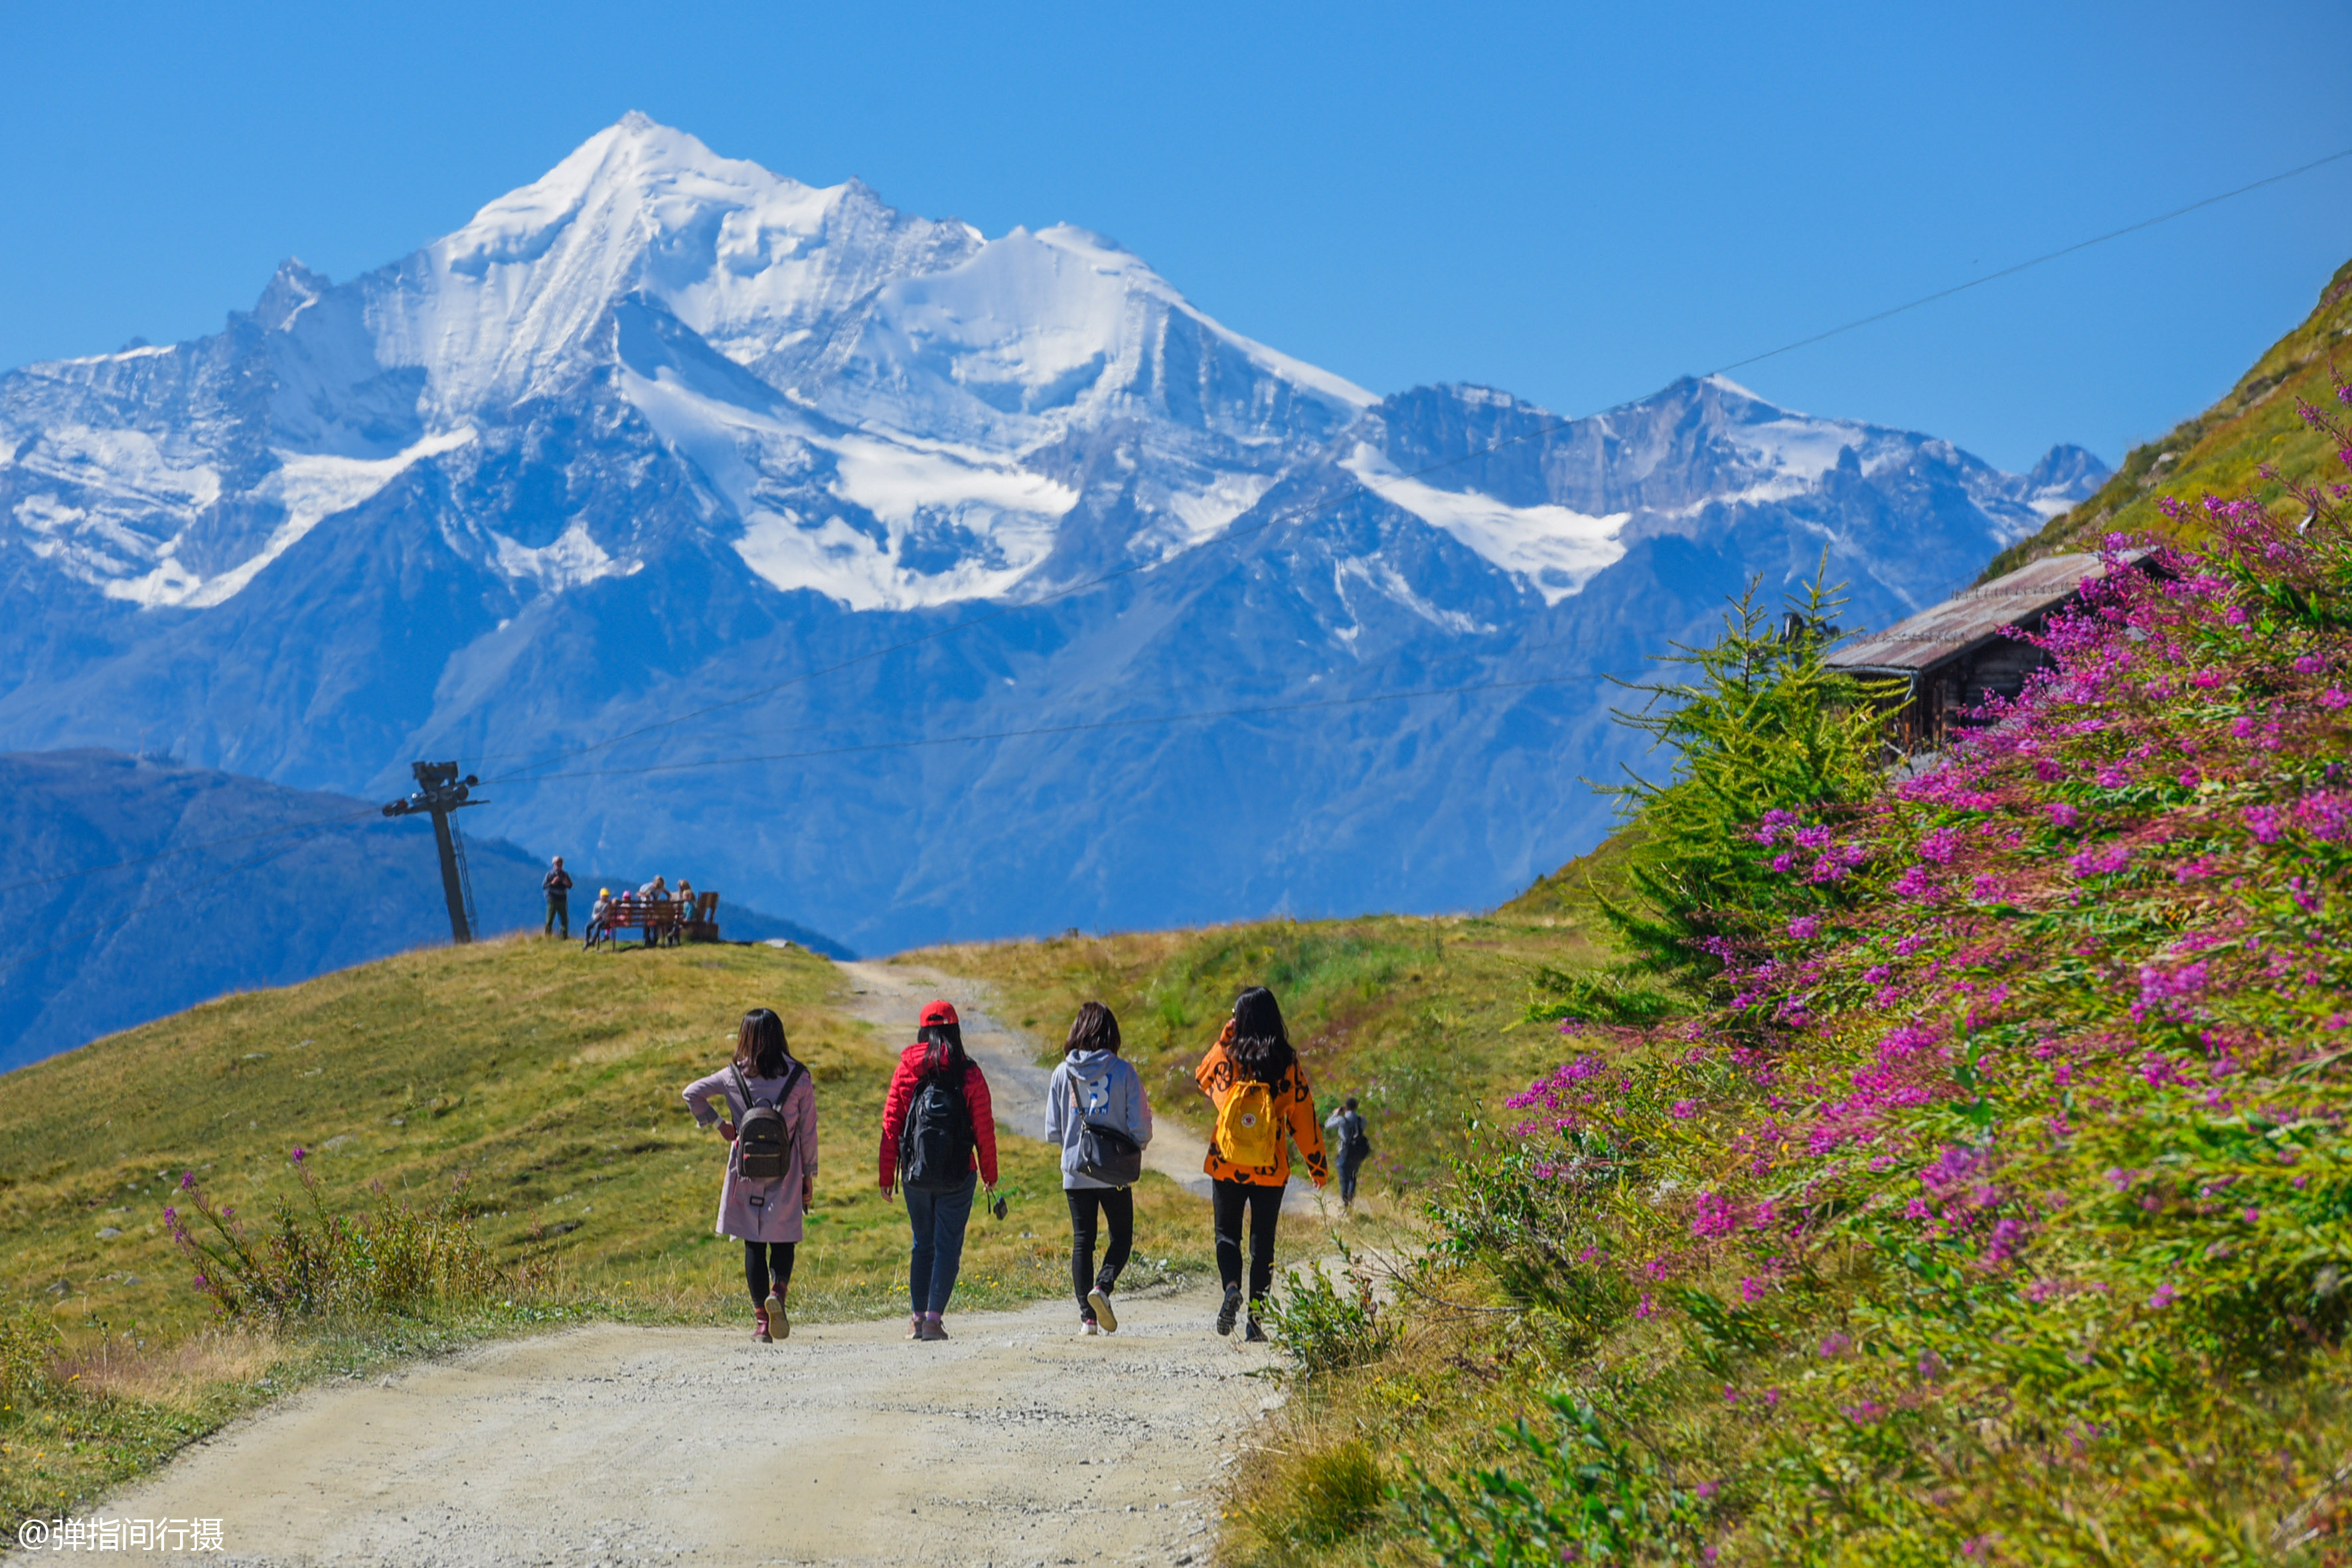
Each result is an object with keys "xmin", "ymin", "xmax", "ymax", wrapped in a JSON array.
[{"xmin": 1985, "ymin": 264, "xmax": 2352, "ymax": 578}]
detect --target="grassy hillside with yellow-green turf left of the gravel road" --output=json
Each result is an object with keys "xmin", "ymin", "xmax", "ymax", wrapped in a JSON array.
[{"xmin": 0, "ymin": 938, "xmax": 1209, "ymax": 1509}]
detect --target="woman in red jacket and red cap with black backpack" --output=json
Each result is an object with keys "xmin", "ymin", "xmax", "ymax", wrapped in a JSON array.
[{"xmin": 882, "ymin": 1002, "xmax": 1002, "ymax": 1340}]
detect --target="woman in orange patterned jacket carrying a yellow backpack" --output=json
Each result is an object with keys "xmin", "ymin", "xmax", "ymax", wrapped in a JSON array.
[{"xmin": 1192, "ymin": 985, "xmax": 1331, "ymax": 1340}]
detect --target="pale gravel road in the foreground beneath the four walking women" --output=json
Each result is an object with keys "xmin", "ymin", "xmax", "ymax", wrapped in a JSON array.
[{"xmin": 104, "ymin": 1289, "xmax": 1270, "ymax": 1568}]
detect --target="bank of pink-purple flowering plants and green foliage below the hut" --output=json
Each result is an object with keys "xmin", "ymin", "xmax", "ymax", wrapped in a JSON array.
[{"xmin": 1404, "ymin": 386, "xmax": 2352, "ymax": 1563}]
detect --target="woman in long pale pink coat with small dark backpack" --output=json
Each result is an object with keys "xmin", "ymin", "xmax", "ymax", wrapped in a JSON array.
[{"xmin": 682, "ymin": 1006, "xmax": 816, "ymax": 1345}]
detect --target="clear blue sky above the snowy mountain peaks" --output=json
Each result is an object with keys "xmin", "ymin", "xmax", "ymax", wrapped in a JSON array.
[{"xmin": 0, "ymin": 0, "xmax": 2352, "ymax": 468}]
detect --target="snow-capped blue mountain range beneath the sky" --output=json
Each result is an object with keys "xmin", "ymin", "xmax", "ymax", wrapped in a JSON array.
[{"xmin": 0, "ymin": 116, "xmax": 2105, "ymax": 950}]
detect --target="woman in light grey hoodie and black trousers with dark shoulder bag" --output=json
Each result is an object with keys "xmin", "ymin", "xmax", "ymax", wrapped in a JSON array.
[{"xmin": 1044, "ymin": 1002, "xmax": 1152, "ymax": 1333}]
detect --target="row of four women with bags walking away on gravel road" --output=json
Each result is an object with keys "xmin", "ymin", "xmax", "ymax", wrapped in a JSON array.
[{"xmin": 684, "ymin": 987, "xmax": 1331, "ymax": 1342}]
